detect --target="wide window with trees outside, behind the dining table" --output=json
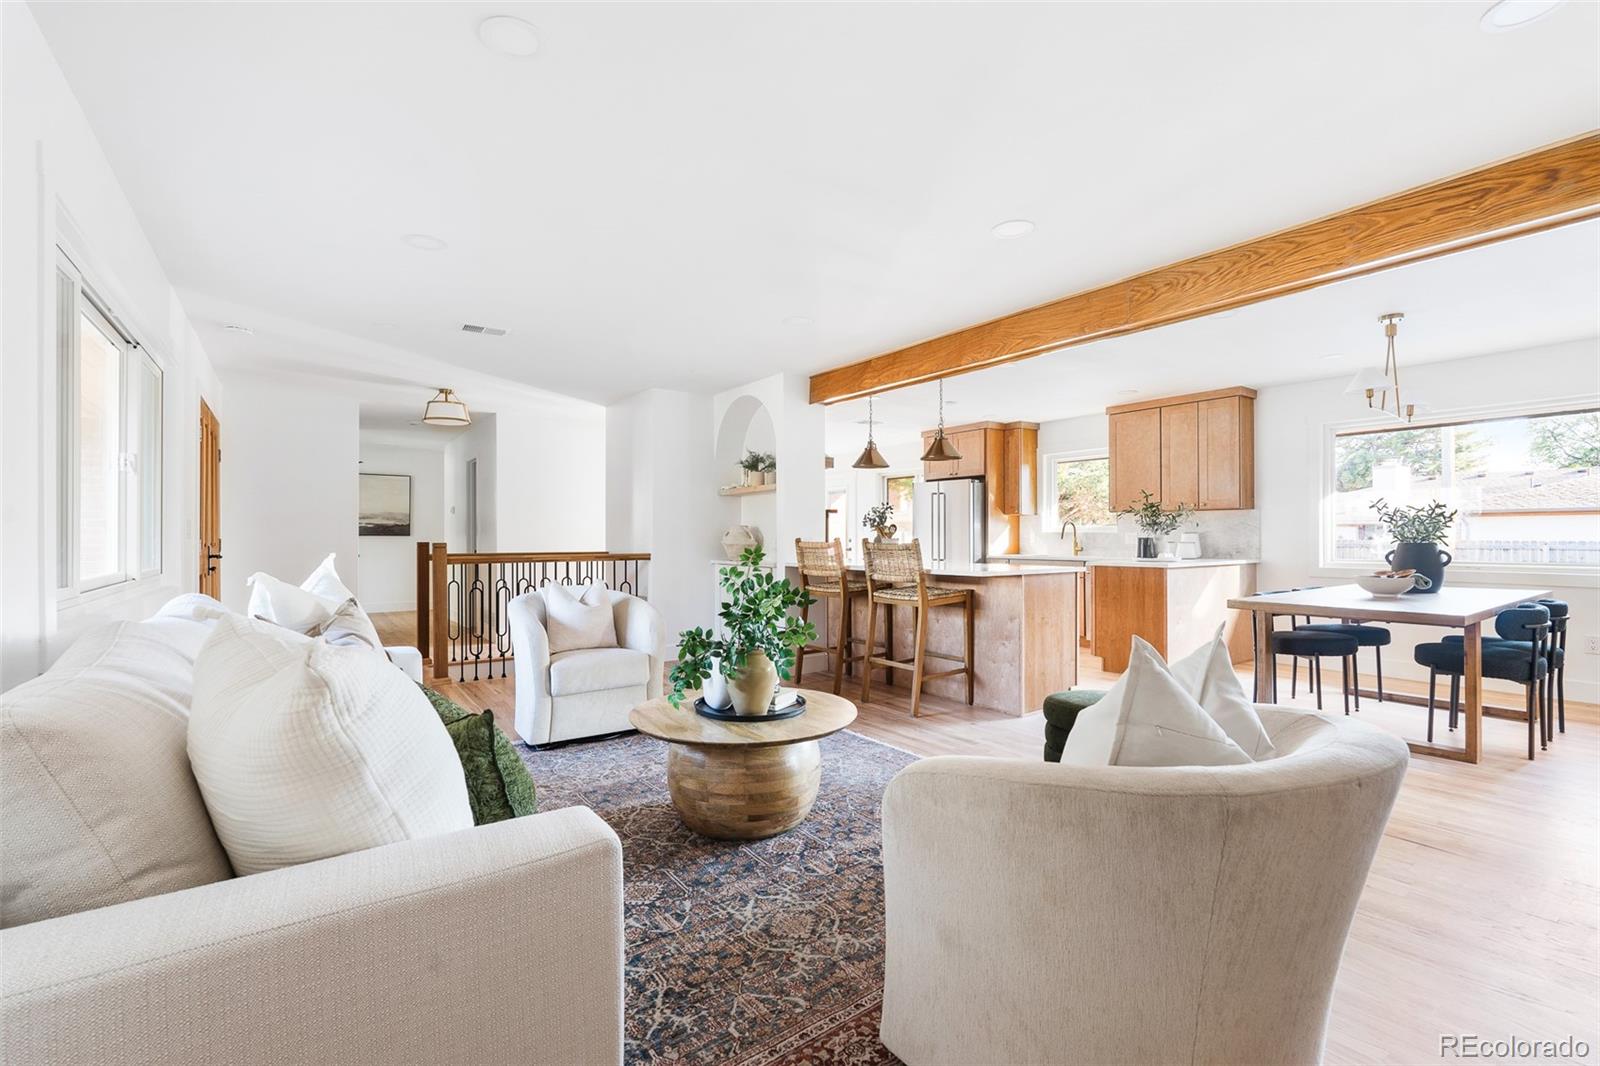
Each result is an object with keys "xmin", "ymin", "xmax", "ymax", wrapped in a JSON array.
[{"xmin": 1330, "ymin": 410, "xmax": 1600, "ymax": 568}]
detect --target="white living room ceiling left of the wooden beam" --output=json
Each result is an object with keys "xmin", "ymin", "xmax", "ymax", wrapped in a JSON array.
[{"xmin": 34, "ymin": 0, "xmax": 1600, "ymax": 402}]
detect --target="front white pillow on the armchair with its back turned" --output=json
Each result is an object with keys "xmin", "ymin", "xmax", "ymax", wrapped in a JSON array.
[{"xmin": 1061, "ymin": 637, "xmax": 1250, "ymax": 767}]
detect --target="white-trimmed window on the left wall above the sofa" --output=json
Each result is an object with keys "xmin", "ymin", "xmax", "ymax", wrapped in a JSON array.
[{"xmin": 56, "ymin": 253, "xmax": 162, "ymax": 594}]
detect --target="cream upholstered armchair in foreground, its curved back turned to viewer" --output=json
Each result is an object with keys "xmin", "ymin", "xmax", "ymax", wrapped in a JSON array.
[{"xmin": 882, "ymin": 706, "xmax": 1408, "ymax": 1066}]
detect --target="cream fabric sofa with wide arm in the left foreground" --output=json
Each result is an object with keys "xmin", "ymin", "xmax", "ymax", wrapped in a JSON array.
[{"xmin": 0, "ymin": 602, "xmax": 622, "ymax": 1066}]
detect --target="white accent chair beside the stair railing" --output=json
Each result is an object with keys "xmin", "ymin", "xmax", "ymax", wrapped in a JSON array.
[{"xmin": 509, "ymin": 589, "xmax": 666, "ymax": 744}]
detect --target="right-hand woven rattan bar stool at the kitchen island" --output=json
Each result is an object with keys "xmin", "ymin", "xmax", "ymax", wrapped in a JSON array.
[{"xmin": 861, "ymin": 539, "xmax": 973, "ymax": 717}]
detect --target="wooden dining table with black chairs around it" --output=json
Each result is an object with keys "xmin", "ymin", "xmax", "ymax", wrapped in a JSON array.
[{"xmin": 1227, "ymin": 584, "xmax": 1550, "ymax": 762}]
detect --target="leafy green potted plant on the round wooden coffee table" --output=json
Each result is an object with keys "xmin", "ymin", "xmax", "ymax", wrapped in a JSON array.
[{"xmin": 667, "ymin": 547, "xmax": 816, "ymax": 715}]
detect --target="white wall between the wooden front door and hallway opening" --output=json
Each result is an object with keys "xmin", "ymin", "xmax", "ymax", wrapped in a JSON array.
[{"xmin": 222, "ymin": 371, "xmax": 356, "ymax": 610}]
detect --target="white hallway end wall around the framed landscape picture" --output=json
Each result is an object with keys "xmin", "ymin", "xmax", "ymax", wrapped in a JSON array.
[{"xmin": 355, "ymin": 434, "xmax": 445, "ymax": 611}]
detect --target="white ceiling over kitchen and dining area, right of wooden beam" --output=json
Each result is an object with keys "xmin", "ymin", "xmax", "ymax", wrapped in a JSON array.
[{"xmin": 826, "ymin": 221, "xmax": 1600, "ymax": 444}]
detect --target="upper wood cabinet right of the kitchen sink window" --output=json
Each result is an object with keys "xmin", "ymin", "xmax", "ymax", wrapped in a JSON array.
[{"xmin": 1106, "ymin": 387, "xmax": 1256, "ymax": 511}]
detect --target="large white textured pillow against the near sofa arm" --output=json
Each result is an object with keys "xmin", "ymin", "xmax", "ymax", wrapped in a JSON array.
[{"xmin": 189, "ymin": 618, "xmax": 472, "ymax": 874}]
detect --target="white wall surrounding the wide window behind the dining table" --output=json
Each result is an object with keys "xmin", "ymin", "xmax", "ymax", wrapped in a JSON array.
[{"xmin": 1256, "ymin": 339, "xmax": 1600, "ymax": 701}]
